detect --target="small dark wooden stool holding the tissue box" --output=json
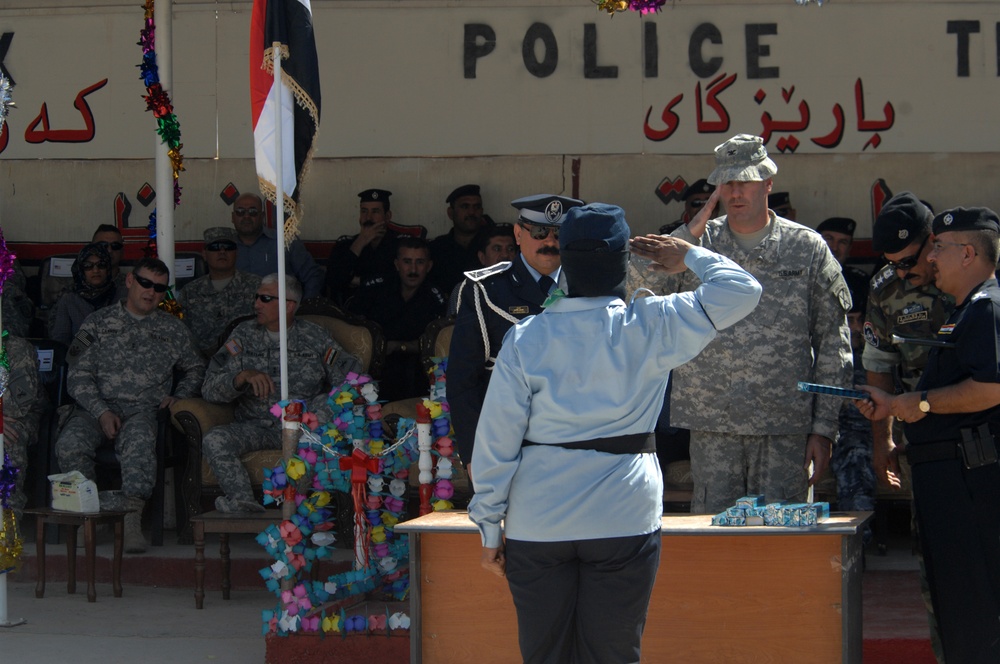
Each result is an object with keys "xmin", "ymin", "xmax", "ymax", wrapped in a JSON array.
[{"xmin": 24, "ymin": 507, "xmax": 128, "ymax": 602}]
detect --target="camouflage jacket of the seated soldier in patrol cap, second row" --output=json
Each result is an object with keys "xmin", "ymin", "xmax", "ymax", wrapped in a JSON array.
[{"xmin": 177, "ymin": 270, "xmax": 260, "ymax": 357}]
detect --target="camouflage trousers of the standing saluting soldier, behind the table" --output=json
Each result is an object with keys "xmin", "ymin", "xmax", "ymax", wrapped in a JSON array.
[{"xmin": 691, "ymin": 431, "xmax": 808, "ymax": 514}]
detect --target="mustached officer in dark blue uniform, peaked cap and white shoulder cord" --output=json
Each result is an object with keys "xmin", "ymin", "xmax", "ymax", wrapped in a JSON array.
[{"xmin": 447, "ymin": 194, "xmax": 583, "ymax": 466}]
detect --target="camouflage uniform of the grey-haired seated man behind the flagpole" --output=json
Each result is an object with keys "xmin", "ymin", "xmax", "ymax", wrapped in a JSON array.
[{"xmin": 202, "ymin": 320, "xmax": 361, "ymax": 504}]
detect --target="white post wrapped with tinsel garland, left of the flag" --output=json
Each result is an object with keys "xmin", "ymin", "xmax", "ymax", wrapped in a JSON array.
[{"xmin": 153, "ymin": 0, "xmax": 177, "ymax": 286}]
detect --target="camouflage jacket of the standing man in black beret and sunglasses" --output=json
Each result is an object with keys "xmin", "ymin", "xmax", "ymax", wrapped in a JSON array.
[{"xmin": 863, "ymin": 265, "xmax": 955, "ymax": 391}]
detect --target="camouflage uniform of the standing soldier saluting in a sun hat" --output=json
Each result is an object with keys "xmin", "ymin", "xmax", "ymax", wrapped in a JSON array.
[{"xmin": 630, "ymin": 211, "xmax": 853, "ymax": 512}]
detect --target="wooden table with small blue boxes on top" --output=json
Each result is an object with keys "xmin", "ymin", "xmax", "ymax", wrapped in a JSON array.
[{"xmin": 396, "ymin": 512, "xmax": 871, "ymax": 664}]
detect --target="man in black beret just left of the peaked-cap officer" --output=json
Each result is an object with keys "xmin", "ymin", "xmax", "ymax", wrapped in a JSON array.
[{"xmin": 429, "ymin": 184, "xmax": 486, "ymax": 293}]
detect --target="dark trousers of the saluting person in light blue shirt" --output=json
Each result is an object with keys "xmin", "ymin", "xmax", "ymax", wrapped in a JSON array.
[{"xmin": 506, "ymin": 530, "xmax": 662, "ymax": 664}]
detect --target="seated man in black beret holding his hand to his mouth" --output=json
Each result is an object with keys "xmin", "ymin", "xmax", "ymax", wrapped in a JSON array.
[{"xmin": 324, "ymin": 189, "xmax": 396, "ymax": 306}]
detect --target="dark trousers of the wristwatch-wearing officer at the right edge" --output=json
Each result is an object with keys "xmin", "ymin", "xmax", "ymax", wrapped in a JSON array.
[{"xmin": 913, "ymin": 459, "xmax": 1000, "ymax": 664}]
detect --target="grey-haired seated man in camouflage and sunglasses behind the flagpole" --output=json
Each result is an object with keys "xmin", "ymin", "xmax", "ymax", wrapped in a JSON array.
[{"xmin": 202, "ymin": 274, "xmax": 361, "ymax": 512}]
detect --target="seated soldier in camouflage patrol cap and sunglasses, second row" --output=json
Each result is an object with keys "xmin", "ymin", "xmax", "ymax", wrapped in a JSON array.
[{"xmin": 177, "ymin": 226, "xmax": 260, "ymax": 358}]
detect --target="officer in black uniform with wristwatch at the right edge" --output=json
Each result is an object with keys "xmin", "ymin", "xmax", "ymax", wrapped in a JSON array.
[{"xmin": 856, "ymin": 208, "xmax": 1000, "ymax": 664}]
